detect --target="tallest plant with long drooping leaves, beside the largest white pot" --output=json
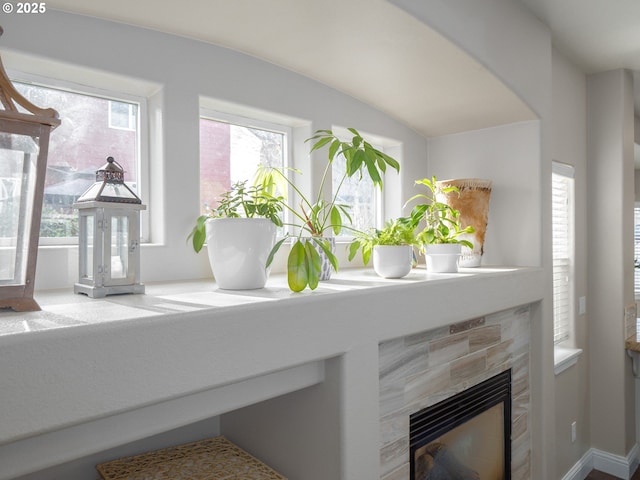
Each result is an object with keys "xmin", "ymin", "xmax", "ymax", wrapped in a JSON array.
[{"xmin": 256, "ymin": 128, "xmax": 400, "ymax": 292}]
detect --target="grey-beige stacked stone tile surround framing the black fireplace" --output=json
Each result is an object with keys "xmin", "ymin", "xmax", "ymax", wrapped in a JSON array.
[{"xmin": 379, "ymin": 306, "xmax": 531, "ymax": 480}]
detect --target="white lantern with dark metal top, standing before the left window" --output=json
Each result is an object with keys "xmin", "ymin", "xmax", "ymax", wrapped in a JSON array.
[{"xmin": 74, "ymin": 157, "xmax": 146, "ymax": 298}]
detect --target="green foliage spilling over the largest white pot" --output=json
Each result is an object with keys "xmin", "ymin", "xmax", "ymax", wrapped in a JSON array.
[{"xmin": 187, "ymin": 180, "xmax": 284, "ymax": 252}]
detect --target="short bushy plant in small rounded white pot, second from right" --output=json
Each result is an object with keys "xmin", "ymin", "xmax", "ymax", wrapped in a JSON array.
[{"xmin": 349, "ymin": 217, "xmax": 418, "ymax": 278}]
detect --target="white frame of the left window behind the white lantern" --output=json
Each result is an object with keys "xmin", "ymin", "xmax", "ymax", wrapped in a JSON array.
[{"xmin": 7, "ymin": 69, "xmax": 151, "ymax": 246}]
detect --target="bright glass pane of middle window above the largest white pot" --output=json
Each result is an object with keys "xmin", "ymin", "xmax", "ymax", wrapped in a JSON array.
[{"xmin": 200, "ymin": 112, "xmax": 290, "ymax": 213}]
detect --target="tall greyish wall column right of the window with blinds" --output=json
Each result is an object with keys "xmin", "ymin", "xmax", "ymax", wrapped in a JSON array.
[{"xmin": 587, "ymin": 70, "xmax": 635, "ymax": 456}]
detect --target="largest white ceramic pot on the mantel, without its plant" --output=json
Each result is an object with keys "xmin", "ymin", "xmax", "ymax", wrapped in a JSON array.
[{"xmin": 206, "ymin": 218, "xmax": 276, "ymax": 290}]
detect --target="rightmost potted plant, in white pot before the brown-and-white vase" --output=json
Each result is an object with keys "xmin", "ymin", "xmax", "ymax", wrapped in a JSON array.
[{"xmin": 405, "ymin": 176, "xmax": 474, "ymax": 273}]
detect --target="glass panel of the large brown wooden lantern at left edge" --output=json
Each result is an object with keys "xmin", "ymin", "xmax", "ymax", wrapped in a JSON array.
[{"xmin": 0, "ymin": 132, "xmax": 39, "ymax": 285}]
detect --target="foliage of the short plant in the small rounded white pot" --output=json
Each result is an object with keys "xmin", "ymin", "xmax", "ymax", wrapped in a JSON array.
[{"xmin": 349, "ymin": 217, "xmax": 418, "ymax": 265}]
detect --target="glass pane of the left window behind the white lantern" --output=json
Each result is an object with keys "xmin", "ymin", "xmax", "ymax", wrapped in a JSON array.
[{"xmin": 11, "ymin": 81, "xmax": 144, "ymax": 245}]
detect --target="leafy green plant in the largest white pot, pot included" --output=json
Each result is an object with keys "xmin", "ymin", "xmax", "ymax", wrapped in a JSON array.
[{"xmin": 189, "ymin": 181, "xmax": 282, "ymax": 290}]
